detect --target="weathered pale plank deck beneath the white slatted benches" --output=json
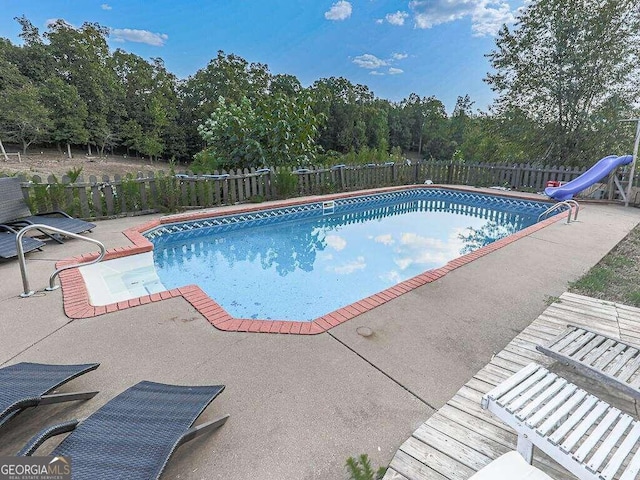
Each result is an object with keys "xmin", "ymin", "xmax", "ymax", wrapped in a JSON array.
[{"xmin": 384, "ymin": 293, "xmax": 640, "ymax": 480}]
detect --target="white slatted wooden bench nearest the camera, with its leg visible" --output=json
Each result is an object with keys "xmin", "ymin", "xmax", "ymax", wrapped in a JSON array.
[{"xmin": 482, "ymin": 363, "xmax": 640, "ymax": 480}]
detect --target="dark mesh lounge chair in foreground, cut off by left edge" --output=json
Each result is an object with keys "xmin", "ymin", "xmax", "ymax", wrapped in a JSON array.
[{"xmin": 0, "ymin": 362, "xmax": 100, "ymax": 426}]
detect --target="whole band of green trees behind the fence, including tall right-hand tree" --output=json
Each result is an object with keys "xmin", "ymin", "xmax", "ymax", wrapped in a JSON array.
[{"xmin": 0, "ymin": 12, "xmax": 640, "ymax": 171}]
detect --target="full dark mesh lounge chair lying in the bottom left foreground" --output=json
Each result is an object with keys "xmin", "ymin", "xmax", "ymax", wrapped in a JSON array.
[{"xmin": 18, "ymin": 382, "xmax": 229, "ymax": 480}]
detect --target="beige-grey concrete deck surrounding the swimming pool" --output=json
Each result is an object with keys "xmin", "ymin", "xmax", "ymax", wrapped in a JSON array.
[{"xmin": 0, "ymin": 188, "xmax": 640, "ymax": 480}]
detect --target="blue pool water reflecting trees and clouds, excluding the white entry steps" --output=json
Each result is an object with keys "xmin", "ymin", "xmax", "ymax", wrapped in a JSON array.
[{"xmin": 145, "ymin": 189, "xmax": 548, "ymax": 321}]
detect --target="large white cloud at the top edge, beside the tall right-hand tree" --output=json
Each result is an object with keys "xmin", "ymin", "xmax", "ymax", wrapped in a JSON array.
[{"xmin": 409, "ymin": 0, "xmax": 515, "ymax": 36}]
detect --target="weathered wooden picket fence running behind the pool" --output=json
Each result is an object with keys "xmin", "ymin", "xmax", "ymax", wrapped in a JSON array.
[{"xmin": 6, "ymin": 161, "xmax": 632, "ymax": 219}]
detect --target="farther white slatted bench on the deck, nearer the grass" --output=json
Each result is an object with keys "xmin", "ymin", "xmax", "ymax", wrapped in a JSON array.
[{"xmin": 536, "ymin": 325, "xmax": 640, "ymax": 400}]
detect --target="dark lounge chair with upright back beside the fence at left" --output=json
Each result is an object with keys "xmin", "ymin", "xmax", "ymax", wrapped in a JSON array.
[{"xmin": 0, "ymin": 177, "xmax": 95, "ymax": 243}]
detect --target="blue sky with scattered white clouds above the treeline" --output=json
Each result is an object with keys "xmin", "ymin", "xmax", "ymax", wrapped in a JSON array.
[{"xmin": 0, "ymin": 0, "xmax": 526, "ymax": 111}]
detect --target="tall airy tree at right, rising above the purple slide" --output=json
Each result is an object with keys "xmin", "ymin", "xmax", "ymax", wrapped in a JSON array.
[{"xmin": 486, "ymin": 0, "xmax": 640, "ymax": 164}]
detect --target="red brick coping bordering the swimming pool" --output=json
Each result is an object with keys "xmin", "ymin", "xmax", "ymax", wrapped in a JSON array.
[{"xmin": 56, "ymin": 185, "xmax": 568, "ymax": 335}]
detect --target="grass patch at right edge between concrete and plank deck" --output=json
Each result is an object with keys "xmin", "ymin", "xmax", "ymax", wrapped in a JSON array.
[{"xmin": 569, "ymin": 226, "xmax": 640, "ymax": 307}]
